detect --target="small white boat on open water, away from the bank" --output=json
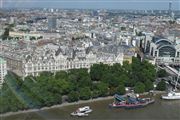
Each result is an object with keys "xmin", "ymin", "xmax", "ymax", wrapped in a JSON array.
[{"xmin": 71, "ymin": 106, "xmax": 92, "ymax": 117}]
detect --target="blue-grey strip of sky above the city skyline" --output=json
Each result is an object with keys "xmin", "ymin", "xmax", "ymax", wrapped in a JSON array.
[{"xmin": 3, "ymin": 0, "xmax": 180, "ymax": 10}]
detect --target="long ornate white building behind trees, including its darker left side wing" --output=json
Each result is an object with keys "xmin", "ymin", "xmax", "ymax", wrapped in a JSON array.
[{"xmin": 1, "ymin": 44, "xmax": 127, "ymax": 77}]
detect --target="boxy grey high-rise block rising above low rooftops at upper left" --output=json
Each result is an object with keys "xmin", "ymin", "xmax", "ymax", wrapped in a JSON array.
[{"xmin": 48, "ymin": 16, "xmax": 57, "ymax": 31}]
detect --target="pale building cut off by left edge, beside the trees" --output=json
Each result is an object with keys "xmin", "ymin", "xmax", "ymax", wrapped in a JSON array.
[{"xmin": 0, "ymin": 58, "xmax": 7, "ymax": 86}]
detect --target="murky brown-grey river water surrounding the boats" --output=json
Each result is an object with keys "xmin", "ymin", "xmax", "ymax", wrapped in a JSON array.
[{"xmin": 1, "ymin": 94, "xmax": 180, "ymax": 120}]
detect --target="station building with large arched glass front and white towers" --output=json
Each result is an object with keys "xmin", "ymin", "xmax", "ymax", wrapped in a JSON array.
[{"xmin": 149, "ymin": 38, "xmax": 180, "ymax": 65}]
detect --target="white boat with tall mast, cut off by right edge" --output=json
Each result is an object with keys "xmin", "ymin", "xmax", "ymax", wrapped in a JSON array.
[{"xmin": 161, "ymin": 70, "xmax": 180, "ymax": 100}]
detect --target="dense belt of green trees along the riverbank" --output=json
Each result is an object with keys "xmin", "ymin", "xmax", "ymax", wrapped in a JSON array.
[{"xmin": 0, "ymin": 58, "xmax": 159, "ymax": 113}]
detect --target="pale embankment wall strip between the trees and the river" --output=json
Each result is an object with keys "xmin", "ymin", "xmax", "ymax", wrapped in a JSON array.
[{"xmin": 0, "ymin": 91, "xmax": 165, "ymax": 117}]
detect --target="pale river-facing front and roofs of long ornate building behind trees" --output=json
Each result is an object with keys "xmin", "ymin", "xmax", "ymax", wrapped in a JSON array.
[{"xmin": 22, "ymin": 46, "xmax": 124, "ymax": 76}]
